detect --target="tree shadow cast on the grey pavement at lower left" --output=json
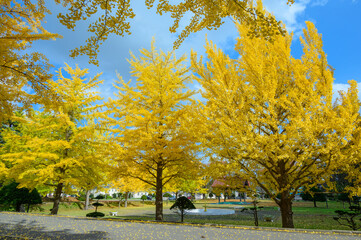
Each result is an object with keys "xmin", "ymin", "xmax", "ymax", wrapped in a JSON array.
[{"xmin": 0, "ymin": 220, "xmax": 108, "ymax": 240}]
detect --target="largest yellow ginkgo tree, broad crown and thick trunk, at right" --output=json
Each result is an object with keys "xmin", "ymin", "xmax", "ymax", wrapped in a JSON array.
[{"xmin": 192, "ymin": 18, "xmax": 358, "ymax": 228}]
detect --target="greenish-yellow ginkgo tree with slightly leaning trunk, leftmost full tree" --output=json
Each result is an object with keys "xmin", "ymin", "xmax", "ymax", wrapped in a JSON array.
[{"xmin": 1, "ymin": 65, "xmax": 106, "ymax": 214}]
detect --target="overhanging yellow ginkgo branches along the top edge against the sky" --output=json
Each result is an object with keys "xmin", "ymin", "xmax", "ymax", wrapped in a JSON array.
[{"xmin": 51, "ymin": 0, "xmax": 294, "ymax": 65}]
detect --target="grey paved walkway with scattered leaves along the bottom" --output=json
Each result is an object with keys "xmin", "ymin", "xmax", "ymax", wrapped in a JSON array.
[{"xmin": 0, "ymin": 212, "xmax": 361, "ymax": 240}]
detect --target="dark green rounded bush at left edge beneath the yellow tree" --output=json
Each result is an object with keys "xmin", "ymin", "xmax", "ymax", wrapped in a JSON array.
[{"xmin": 0, "ymin": 182, "xmax": 42, "ymax": 212}]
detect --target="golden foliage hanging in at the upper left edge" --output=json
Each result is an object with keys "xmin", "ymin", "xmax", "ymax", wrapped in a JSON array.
[{"xmin": 0, "ymin": 0, "xmax": 59, "ymax": 122}]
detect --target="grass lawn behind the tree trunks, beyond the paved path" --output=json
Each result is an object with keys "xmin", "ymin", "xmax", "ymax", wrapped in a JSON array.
[{"xmin": 23, "ymin": 200, "xmax": 358, "ymax": 230}]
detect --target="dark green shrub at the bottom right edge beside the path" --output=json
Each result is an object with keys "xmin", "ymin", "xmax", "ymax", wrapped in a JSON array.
[{"xmin": 333, "ymin": 206, "xmax": 361, "ymax": 231}]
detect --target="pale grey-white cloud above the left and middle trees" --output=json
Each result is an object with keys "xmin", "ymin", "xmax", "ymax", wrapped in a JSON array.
[{"xmin": 33, "ymin": 1, "xmax": 238, "ymax": 98}]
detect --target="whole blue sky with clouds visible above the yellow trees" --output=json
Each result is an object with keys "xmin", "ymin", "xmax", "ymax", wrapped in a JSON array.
[{"xmin": 32, "ymin": 0, "xmax": 361, "ymax": 98}]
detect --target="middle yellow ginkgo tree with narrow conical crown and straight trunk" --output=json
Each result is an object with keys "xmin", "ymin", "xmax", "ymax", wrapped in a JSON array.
[{"xmin": 104, "ymin": 39, "xmax": 198, "ymax": 220}]
